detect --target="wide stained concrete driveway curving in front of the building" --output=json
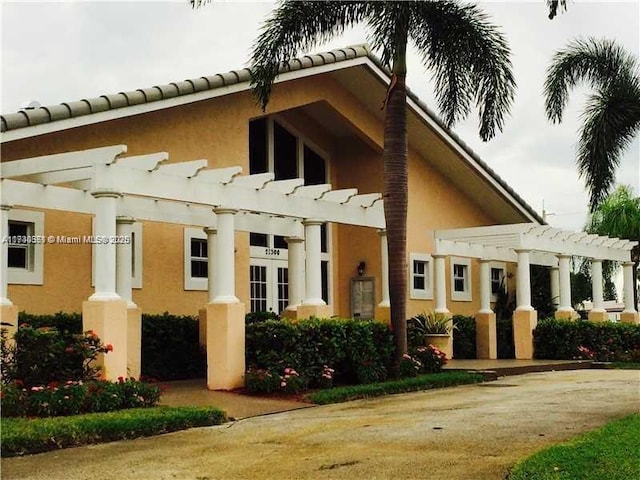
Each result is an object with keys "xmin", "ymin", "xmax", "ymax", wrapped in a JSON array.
[{"xmin": 2, "ymin": 370, "xmax": 640, "ymax": 480}]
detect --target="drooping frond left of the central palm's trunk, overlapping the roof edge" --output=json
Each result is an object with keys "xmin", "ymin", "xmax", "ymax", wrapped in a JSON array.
[{"xmin": 250, "ymin": 0, "xmax": 369, "ymax": 109}]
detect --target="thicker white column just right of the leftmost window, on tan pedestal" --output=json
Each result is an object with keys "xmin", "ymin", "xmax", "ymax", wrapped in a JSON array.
[{"xmin": 89, "ymin": 190, "xmax": 121, "ymax": 301}]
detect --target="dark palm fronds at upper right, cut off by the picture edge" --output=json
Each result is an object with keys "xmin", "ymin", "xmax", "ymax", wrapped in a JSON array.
[{"xmin": 544, "ymin": 38, "xmax": 640, "ymax": 212}]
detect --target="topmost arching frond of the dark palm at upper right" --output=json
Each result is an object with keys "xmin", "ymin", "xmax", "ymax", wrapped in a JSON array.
[{"xmin": 544, "ymin": 38, "xmax": 638, "ymax": 123}]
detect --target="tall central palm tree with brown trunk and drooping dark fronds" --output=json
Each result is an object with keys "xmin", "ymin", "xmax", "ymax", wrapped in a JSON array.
[{"xmin": 192, "ymin": 0, "xmax": 515, "ymax": 361}]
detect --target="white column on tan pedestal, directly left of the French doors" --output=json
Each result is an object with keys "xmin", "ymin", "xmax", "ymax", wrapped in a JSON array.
[{"xmin": 211, "ymin": 208, "xmax": 239, "ymax": 303}]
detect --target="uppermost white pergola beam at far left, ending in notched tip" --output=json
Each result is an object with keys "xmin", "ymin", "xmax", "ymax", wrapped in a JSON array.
[{"xmin": 0, "ymin": 145, "xmax": 127, "ymax": 178}]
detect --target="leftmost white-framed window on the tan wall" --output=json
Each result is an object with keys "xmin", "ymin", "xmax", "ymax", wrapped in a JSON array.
[{"xmin": 7, "ymin": 208, "xmax": 44, "ymax": 285}]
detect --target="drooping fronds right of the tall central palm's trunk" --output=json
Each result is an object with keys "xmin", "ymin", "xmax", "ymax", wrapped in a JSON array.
[{"xmin": 409, "ymin": 0, "xmax": 515, "ymax": 141}]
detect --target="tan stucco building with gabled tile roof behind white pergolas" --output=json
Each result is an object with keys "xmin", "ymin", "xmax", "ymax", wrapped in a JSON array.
[{"xmin": 1, "ymin": 46, "xmax": 636, "ymax": 388}]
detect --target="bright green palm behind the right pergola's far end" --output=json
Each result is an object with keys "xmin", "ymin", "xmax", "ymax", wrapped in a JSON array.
[{"xmin": 586, "ymin": 185, "xmax": 640, "ymax": 305}]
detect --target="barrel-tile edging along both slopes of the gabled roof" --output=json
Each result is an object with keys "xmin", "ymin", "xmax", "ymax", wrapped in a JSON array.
[{"xmin": 0, "ymin": 44, "xmax": 546, "ymax": 224}]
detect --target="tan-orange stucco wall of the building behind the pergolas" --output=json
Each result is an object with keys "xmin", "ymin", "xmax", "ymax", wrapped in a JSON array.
[{"xmin": 2, "ymin": 75, "xmax": 516, "ymax": 315}]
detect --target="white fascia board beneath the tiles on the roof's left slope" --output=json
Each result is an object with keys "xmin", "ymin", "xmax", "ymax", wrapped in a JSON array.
[{"xmin": 0, "ymin": 57, "xmax": 375, "ymax": 143}]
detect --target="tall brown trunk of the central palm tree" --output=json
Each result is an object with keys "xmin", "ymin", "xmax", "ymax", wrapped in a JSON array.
[{"xmin": 382, "ymin": 42, "xmax": 409, "ymax": 366}]
